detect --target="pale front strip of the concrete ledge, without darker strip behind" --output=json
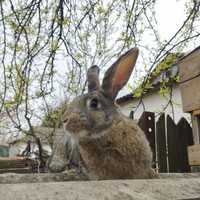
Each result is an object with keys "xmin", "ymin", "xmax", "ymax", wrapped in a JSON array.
[{"xmin": 0, "ymin": 178, "xmax": 200, "ymax": 200}]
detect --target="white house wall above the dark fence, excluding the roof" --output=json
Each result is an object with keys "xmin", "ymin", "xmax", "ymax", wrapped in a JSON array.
[{"xmin": 120, "ymin": 86, "xmax": 192, "ymax": 123}]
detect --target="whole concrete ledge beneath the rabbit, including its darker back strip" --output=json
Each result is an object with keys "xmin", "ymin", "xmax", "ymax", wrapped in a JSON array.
[{"xmin": 0, "ymin": 171, "xmax": 200, "ymax": 200}]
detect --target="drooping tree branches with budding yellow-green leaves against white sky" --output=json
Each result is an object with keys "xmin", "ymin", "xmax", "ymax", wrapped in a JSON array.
[{"xmin": 0, "ymin": 0, "xmax": 200, "ymax": 159}]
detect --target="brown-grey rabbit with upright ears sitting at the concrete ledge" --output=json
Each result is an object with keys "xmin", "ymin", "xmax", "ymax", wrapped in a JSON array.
[{"xmin": 50, "ymin": 47, "xmax": 157, "ymax": 180}]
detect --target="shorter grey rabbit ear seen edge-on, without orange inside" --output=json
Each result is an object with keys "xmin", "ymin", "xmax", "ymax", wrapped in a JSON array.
[{"xmin": 87, "ymin": 65, "xmax": 100, "ymax": 92}]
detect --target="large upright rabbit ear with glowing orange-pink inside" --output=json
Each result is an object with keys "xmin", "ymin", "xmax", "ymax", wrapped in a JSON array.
[{"xmin": 102, "ymin": 47, "xmax": 139, "ymax": 100}]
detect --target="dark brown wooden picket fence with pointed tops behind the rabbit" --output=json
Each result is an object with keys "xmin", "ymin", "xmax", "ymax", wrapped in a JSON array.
[{"xmin": 138, "ymin": 112, "xmax": 193, "ymax": 173}]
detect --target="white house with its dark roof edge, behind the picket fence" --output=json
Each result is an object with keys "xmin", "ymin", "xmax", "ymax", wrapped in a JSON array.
[{"xmin": 116, "ymin": 54, "xmax": 192, "ymax": 123}]
